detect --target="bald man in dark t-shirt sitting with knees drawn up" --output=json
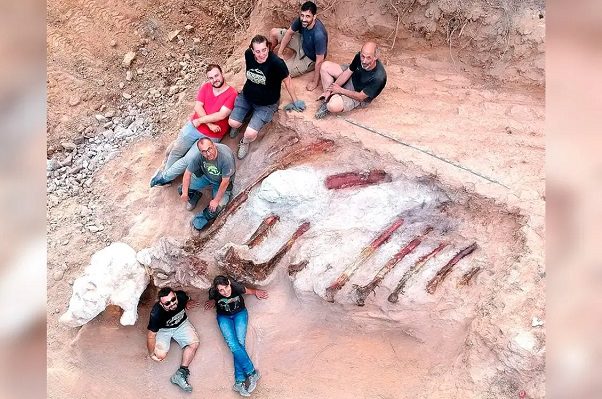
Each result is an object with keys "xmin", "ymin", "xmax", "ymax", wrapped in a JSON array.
[{"xmin": 316, "ymin": 42, "xmax": 387, "ymax": 119}]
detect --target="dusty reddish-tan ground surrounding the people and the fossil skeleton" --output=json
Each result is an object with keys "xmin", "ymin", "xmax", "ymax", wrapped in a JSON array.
[{"xmin": 47, "ymin": 0, "xmax": 545, "ymax": 398}]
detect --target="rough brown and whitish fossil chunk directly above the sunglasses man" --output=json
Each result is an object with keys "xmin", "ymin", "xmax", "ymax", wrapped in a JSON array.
[{"xmin": 136, "ymin": 237, "xmax": 211, "ymax": 289}]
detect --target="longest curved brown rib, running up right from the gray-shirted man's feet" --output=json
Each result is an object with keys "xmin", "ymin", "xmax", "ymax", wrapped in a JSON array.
[{"xmin": 186, "ymin": 139, "xmax": 335, "ymax": 252}]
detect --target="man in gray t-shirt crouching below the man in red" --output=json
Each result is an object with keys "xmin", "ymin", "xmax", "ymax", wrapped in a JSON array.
[{"xmin": 179, "ymin": 138, "xmax": 236, "ymax": 230}]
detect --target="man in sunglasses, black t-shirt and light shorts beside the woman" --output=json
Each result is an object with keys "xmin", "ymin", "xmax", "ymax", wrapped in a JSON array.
[{"xmin": 146, "ymin": 287, "xmax": 199, "ymax": 392}]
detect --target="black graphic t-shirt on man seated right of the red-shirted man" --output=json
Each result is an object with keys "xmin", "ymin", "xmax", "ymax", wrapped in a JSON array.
[{"xmin": 242, "ymin": 49, "xmax": 288, "ymax": 105}]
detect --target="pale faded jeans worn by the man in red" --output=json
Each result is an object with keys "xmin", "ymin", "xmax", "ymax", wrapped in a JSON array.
[{"xmin": 163, "ymin": 121, "xmax": 220, "ymax": 183}]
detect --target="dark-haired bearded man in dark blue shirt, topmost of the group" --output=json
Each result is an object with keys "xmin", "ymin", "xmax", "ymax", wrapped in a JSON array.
[{"xmin": 270, "ymin": 1, "xmax": 328, "ymax": 91}]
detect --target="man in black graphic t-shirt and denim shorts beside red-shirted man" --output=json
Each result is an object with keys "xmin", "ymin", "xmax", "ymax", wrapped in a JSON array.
[{"xmin": 228, "ymin": 35, "xmax": 305, "ymax": 159}]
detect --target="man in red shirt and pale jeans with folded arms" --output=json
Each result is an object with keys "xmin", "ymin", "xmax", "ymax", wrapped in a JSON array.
[{"xmin": 150, "ymin": 64, "xmax": 238, "ymax": 187}]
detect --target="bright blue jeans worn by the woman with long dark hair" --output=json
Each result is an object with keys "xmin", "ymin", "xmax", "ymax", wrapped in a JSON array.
[{"xmin": 217, "ymin": 309, "xmax": 255, "ymax": 383}]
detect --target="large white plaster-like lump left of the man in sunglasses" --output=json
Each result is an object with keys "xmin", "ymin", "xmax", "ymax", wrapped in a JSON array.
[{"xmin": 60, "ymin": 242, "xmax": 149, "ymax": 327}]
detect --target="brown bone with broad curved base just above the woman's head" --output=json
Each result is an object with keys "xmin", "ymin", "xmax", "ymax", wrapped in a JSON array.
[{"xmin": 218, "ymin": 222, "xmax": 310, "ymax": 283}]
